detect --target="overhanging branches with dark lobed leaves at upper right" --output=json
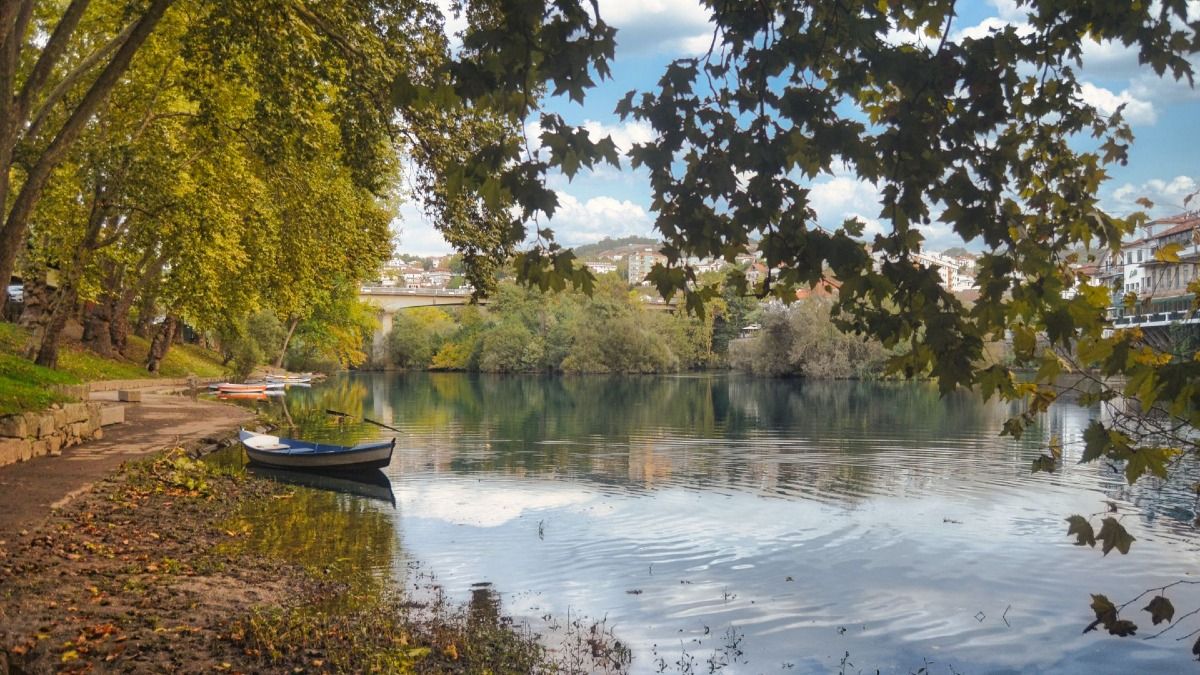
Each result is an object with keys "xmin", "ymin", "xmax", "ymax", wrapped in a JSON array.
[{"xmin": 434, "ymin": 0, "xmax": 1200, "ymax": 650}]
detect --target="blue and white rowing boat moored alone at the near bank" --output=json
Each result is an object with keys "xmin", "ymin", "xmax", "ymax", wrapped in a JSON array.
[{"xmin": 238, "ymin": 429, "xmax": 396, "ymax": 471}]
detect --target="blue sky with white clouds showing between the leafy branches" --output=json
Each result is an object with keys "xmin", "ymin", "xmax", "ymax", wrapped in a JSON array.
[{"xmin": 394, "ymin": 0, "xmax": 1200, "ymax": 256}]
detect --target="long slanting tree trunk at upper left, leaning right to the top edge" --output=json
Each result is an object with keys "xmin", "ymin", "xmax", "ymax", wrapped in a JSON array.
[{"xmin": 0, "ymin": 0, "xmax": 172, "ymax": 315}]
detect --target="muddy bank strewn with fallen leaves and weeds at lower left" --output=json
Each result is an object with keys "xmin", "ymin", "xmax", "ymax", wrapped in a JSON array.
[{"xmin": 0, "ymin": 448, "xmax": 628, "ymax": 673}]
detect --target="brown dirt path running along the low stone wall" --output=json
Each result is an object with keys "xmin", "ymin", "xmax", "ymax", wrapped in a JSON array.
[{"xmin": 0, "ymin": 390, "xmax": 253, "ymax": 542}]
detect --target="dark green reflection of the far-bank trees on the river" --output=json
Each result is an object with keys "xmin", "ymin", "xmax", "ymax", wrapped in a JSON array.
[{"xmin": 352, "ymin": 374, "xmax": 1060, "ymax": 496}]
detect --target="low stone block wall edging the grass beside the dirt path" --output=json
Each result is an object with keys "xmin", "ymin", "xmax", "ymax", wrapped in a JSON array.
[{"xmin": 0, "ymin": 402, "xmax": 125, "ymax": 466}]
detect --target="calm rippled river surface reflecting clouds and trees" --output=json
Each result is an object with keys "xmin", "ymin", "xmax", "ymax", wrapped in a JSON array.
[{"xmin": 241, "ymin": 374, "xmax": 1200, "ymax": 673}]
